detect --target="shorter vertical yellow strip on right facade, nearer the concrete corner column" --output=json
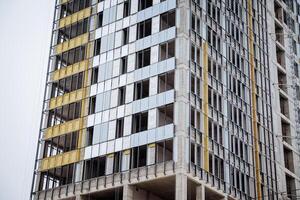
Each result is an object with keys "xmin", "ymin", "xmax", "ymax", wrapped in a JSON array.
[{"xmin": 202, "ymin": 42, "xmax": 209, "ymax": 171}]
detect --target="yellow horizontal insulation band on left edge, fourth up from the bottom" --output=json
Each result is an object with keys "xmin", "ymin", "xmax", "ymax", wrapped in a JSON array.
[{"xmin": 52, "ymin": 60, "xmax": 89, "ymax": 81}]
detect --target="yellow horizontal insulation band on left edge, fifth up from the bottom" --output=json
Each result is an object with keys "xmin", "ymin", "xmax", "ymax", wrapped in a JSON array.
[{"xmin": 55, "ymin": 33, "xmax": 89, "ymax": 54}]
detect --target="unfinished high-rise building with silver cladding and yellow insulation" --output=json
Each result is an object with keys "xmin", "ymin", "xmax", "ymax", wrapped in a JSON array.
[{"xmin": 31, "ymin": 0, "xmax": 300, "ymax": 200}]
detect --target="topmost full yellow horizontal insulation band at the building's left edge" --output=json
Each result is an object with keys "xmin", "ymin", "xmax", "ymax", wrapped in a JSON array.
[{"xmin": 59, "ymin": 7, "xmax": 92, "ymax": 28}]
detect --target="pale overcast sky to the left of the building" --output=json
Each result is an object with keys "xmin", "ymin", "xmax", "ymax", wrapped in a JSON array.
[{"xmin": 0, "ymin": 0, "xmax": 55, "ymax": 200}]
